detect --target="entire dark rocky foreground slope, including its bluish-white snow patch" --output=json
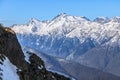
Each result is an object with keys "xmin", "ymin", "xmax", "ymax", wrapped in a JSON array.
[{"xmin": 0, "ymin": 24, "xmax": 70, "ymax": 80}]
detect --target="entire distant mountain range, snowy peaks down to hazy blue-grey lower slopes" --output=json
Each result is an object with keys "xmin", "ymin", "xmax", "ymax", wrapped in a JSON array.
[{"xmin": 11, "ymin": 13, "xmax": 120, "ymax": 79}]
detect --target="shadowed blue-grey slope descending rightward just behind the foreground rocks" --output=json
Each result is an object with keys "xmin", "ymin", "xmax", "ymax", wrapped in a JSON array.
[{"xmin": 24, "ymin": 47, "xmax": 120, "ymax": 80}]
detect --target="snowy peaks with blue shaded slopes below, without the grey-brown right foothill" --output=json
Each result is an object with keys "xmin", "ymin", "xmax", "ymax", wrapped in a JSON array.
[{"xmin": 12, "ymin": 13, "xmax": 120, "ymax": 60}]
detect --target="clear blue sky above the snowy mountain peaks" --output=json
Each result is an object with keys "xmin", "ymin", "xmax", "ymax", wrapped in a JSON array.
[{"xmin": 0, "ymin": 0, "xmax": 120, "ymax": 26}]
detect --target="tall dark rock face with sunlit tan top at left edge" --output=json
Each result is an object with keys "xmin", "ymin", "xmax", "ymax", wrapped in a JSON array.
[{"xmin": 0, "ymin": 26, "xmax": 28, "ymax": 69}]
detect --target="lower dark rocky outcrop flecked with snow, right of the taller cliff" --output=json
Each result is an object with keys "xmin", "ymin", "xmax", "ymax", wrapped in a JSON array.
[{"xmin": 18, "ymin": 53, "xmax": 69, "ymax": 80}]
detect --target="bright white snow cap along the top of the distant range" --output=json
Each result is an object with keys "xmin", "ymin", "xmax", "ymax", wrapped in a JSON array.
[{"xmin": 12, "ymin": 14, "xmax": 120, "ymax": 46}]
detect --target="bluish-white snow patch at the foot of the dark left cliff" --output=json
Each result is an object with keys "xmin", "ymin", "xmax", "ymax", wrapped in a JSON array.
[{"xmin": 0, "ymin": 58, "xmax": 20, "ymax": 80}]
